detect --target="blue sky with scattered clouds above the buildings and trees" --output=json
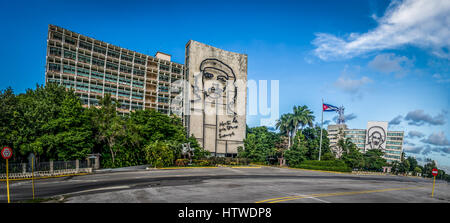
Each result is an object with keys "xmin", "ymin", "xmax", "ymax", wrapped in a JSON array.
[{"xmin": 0, "ymin": 0, "xmax": 450, "ymax": 172}]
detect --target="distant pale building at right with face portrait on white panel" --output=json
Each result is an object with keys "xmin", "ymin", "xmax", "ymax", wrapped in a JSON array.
[{"xmin": 327, "ymin": 121, "xmax": 404, "ymax": 162}]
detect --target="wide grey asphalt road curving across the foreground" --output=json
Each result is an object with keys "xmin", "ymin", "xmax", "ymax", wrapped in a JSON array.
[{"xmin": 0, "ymin": 167, "xmax": 450, "ymax": 203}]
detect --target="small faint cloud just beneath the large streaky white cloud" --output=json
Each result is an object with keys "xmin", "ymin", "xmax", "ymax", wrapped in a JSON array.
[{"xmin": 369, "ymin": 53, "xmax": 413, "ymax": 77}]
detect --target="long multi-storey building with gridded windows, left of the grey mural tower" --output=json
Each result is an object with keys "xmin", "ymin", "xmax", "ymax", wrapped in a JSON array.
[{"xmin": 45, "ymin": 25, "xmax": 184, "ymax": 117}]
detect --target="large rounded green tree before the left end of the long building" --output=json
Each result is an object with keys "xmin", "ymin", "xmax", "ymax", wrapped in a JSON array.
[{"xmin": 7, "ymin": 84, "xmax": 93, "ymax": 161}]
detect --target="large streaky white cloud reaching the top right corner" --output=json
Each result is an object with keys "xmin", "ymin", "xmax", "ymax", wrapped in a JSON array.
[{"xmin": 312, "ymin": 0, "xmax": 450, "ymax": 60}]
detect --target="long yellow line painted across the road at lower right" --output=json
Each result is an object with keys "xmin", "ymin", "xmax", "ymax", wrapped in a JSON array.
[{"xmin": 255, "ymin": 186, "xmax": 425, "ymax": 203}]
